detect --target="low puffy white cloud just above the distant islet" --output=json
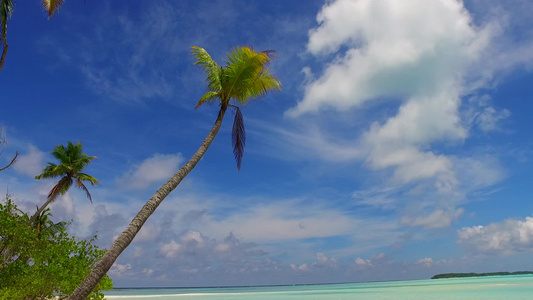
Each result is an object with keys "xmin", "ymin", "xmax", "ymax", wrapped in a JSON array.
[{"xmin": 457, "ymin": 217, "xmax": 533, "ymax": 255}]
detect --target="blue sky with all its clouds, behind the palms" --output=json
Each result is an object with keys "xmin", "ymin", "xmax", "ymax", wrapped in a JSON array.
[{"xmin": 0, "ymin": 0, "xmax": 533, "ymax": 287}]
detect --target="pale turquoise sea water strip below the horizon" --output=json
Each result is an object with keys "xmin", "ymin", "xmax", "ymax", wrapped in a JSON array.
[{"xmin": 106, "ymin": 276, "xmax": 533, "ymax": 300}]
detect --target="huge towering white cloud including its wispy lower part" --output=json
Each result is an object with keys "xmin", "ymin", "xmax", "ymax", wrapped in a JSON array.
[{"xmin": 280, "ymin": 0, "xmax": 532, "ymax": 228}]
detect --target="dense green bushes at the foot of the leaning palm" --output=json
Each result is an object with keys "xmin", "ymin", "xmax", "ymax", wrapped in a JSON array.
[{"xmin": 0, "ymin": 199, "xmax": 113, "ymax": 299}]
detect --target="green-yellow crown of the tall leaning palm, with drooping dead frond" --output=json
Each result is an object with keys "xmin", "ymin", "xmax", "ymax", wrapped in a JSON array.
[{"xmin": 192, "ymin": 47, "xmax": 281, "ymax": 169}]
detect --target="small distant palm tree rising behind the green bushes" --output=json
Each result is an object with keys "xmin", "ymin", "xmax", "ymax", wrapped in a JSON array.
[{"xmin": 31, "ymin": 142, "xmax": 100, "ymax": 220}]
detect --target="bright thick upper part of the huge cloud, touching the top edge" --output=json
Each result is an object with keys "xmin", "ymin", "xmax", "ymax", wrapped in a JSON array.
[{"xmin": 290, "ymin": 0, "xmax": 490, "ymax": 116}]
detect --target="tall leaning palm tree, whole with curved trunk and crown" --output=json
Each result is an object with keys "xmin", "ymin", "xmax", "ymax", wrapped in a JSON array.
[{"xmin": 67, "ymin": 47, "xmax": 281, "ymax": 300}]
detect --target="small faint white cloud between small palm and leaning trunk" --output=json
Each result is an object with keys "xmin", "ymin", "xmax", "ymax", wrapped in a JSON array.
[{"xmin": 117, "ymin": 154, "xmax": 183, "ymax": 189}]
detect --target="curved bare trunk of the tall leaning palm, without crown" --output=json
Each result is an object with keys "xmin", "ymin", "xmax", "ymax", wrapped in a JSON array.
[{"xmin": 67, "ymin": 105, "xmax": 227, "ymax": 300}]
